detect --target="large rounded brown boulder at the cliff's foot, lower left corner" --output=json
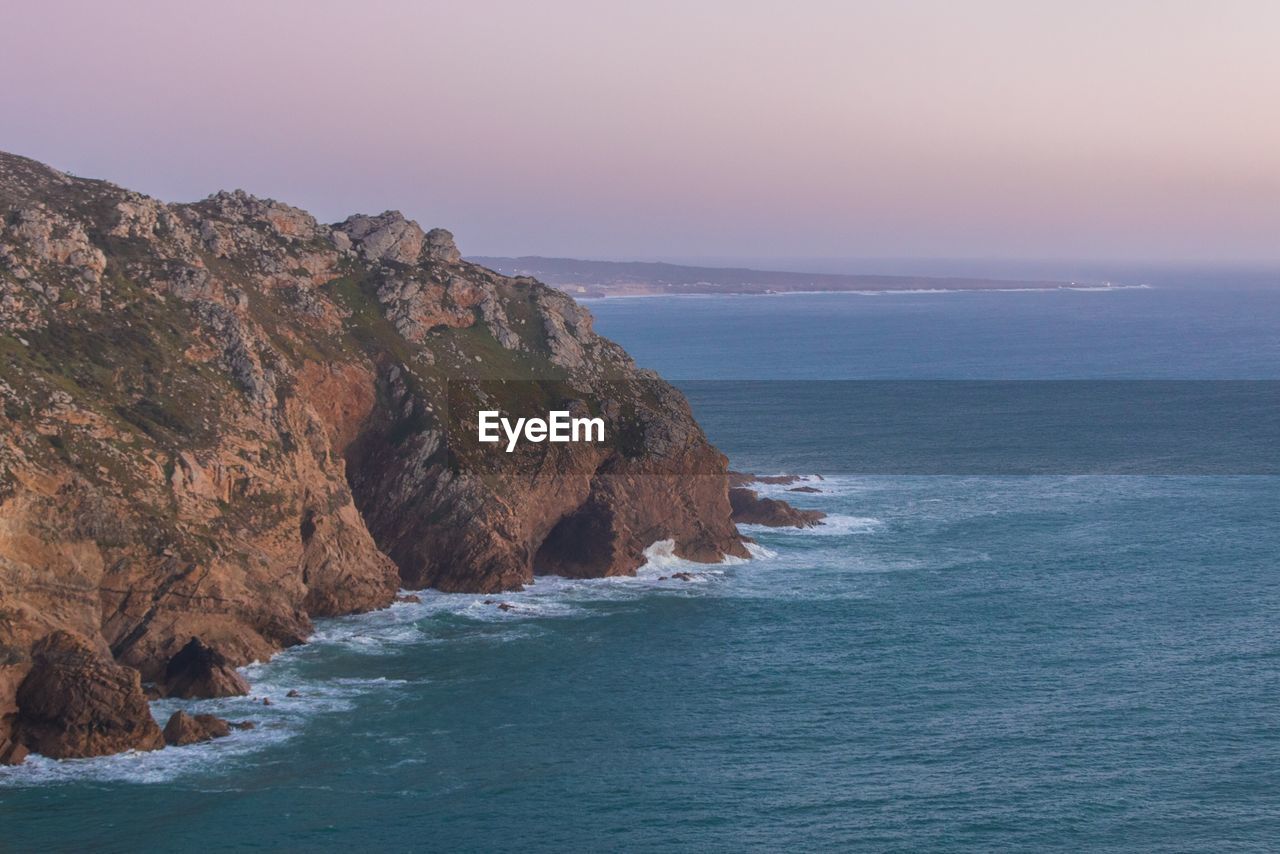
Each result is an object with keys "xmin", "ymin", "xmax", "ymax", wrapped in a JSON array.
[{"xmin": 14, "ymin": 631, "xmax": 164, "ymax": 758}]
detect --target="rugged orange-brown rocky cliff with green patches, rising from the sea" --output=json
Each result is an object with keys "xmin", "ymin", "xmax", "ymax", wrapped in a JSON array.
[{"xmin": 0, "ymin": 155, "xmax": 745, "ymax": 759}]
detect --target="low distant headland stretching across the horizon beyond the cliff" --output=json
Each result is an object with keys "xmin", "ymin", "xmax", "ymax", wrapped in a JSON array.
[{"xmin": 468, "ymin": 255, "xmax": 1111, "ymax": 297}]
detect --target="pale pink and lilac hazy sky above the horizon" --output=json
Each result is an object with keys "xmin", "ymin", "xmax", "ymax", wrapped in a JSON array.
[{"xmin": 0, "ymin": 0, "xmax": 1280, "ymax": 262}]
